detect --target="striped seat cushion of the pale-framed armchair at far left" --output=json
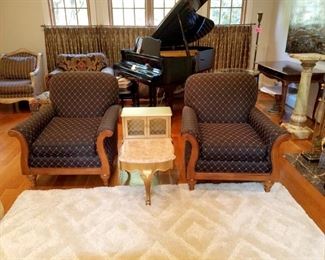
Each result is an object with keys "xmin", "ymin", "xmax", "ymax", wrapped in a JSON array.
[{"xmin": 0, "ymin": 79, "xmax": 34, "ymax": 96}]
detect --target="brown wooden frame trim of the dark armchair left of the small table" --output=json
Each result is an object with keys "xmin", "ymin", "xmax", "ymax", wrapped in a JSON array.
[{"xmin": 8, "ymin": 130, "xmax": 115, "ymax": 187}]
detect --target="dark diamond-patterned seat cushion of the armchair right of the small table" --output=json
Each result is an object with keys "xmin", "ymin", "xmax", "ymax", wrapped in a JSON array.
[{"xmin": 199, "ymin": 123, "xmax": 267, "ymax": 162}]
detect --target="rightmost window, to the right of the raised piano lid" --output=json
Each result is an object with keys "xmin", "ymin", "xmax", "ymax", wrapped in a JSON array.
[{"xmin": 209, "ymin": 0, "xmax": 245, "ymax": 25}]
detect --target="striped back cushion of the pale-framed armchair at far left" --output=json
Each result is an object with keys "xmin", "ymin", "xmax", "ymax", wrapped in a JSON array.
[{"xmin": 0, "ymin": 56, "xmax": 36, "ymax": 79}]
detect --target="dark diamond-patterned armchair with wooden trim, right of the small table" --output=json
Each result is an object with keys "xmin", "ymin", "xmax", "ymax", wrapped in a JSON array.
[{"xmin": 181, "ymin": 73, "xmax": 289, "ymax": 191}]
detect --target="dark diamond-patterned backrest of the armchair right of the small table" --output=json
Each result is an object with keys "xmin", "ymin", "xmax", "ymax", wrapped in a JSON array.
[{"xmin": 184, "ymin": 72, "xmax": 258, "ymax": 123}]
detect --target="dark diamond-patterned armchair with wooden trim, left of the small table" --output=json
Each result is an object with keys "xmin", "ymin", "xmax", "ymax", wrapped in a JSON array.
[{"xmin": 9, "ymin": 72, "xmax": 120, "ymax": 185}]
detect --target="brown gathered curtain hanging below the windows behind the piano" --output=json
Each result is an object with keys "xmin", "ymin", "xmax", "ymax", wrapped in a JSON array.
[{"xmin": 44, "ymin": 25, "xmax": 252, "ymax": 71}]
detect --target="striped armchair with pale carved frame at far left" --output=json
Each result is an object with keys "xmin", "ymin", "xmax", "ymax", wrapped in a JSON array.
[{"xmin": 0, "ymin": 49, "xmax": 44, "ymax": 104}]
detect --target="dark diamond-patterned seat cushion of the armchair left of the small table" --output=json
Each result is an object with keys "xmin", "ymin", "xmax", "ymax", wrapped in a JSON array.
[{"xmin": 32, "ymin": 117, "xmax": 101, "ymax": 157}]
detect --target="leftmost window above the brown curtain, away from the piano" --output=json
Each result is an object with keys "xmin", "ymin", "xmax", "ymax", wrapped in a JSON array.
[{"xmin": 49, "ymin": 0, "xmax": 90, "ymax": 25}]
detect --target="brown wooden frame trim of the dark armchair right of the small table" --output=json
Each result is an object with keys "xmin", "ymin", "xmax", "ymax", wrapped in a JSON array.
[{"xmin": 182, "ymin": 133, "xmax": 290, "ymax": 192}]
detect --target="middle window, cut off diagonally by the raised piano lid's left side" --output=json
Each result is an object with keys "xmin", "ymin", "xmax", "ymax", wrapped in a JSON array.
[{"xmin": 108, "ymin": 0, "xmax": 178, "ymax": 26}]
